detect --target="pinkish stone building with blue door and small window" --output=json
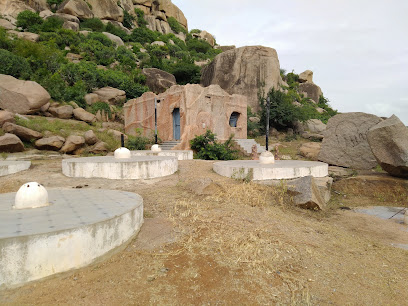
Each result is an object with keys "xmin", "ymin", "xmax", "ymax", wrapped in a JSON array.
[{"xmin": 124, "ymin": 84, "xmax": 247, "ymax": 150}]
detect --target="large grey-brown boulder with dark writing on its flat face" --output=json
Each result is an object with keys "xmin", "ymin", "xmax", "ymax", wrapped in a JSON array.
[{"xmin": 319, "ymin": 113, "xmax": 382, "ymax": 169}]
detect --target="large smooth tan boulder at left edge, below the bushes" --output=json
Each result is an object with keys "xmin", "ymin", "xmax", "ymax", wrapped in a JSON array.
[{"xmin": 0, "ymin": 74, "xmax": 51, "ymax": 114}]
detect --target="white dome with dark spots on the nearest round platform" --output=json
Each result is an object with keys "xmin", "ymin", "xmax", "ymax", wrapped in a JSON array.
[{"xmin": 13, "ymin": 182, "xmax": 50, "ymax": 209}]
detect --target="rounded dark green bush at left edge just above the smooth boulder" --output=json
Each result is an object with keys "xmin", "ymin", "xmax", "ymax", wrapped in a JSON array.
[{"xmin": 0, "ymin": 49, "xmax": 31, "ymax": 79}]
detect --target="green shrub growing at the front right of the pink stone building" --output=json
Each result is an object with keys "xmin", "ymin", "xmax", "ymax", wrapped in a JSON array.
[{"xmin": 190, "ymin": 130, "xmax": 238, "ymax": 160}]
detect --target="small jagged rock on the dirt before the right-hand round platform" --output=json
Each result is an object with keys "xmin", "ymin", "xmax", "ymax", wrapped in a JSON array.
[{"xmin": 287, "ymin": 176, "xmax": 326, "ymax": 210}]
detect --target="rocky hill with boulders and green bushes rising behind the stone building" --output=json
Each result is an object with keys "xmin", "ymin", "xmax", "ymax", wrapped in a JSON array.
[{"xmin": 0, "ymin": 0, "xmax": 335, "ymax": 152}]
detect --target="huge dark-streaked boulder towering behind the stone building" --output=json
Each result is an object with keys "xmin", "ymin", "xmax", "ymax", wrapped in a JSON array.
[{"xmin": 201, "ymin": 46, "xmax": 281, "ymax": 111}]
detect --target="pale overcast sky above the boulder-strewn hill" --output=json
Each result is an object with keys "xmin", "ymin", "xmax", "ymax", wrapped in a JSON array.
[{"xmin": 172, "ymin": 0, "xmax": 408, "ymax": 125}]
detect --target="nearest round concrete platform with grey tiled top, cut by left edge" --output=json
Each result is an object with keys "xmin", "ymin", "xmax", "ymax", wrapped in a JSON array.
[{"xmin": 0, "ymin": 189, "xmax": 143, "ymax": 287}]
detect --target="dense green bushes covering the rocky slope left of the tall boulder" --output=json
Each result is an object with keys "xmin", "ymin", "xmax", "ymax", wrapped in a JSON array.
[{"xmin": 0, "ymin": 10, "xmax": 221, "ymax": 106}]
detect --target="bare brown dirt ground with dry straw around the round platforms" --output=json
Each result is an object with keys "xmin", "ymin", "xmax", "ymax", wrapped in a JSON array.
[{"xmin": 0, "ymin": 160, "xmax": 408, "ymax": 305}]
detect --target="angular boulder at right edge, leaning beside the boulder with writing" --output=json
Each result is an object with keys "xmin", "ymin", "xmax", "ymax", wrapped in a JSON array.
[{"xmin": 367, "ymin": 115, "xmax": 408, "ymax": 178}]
